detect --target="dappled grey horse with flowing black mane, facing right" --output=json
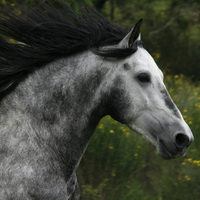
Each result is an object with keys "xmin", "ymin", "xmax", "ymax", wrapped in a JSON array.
[{"xmin": 0, "ymin": 5, "xmax": 193, "ymax": 200}]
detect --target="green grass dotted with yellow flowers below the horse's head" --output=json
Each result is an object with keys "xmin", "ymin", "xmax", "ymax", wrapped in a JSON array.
[{"xmin": 78, "ymin": 76, "xmax": 200, "ymax": 200}]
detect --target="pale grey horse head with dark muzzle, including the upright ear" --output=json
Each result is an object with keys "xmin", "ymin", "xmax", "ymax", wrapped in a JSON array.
[{"xmin": 102, "ymin": 20, "xmax": 193, "ymax": 159}]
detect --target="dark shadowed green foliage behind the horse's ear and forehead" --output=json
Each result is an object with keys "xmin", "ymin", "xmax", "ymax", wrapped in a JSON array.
[{"xmin": 102, "ymin": 0, "xmax": 200, "ymax": 80}]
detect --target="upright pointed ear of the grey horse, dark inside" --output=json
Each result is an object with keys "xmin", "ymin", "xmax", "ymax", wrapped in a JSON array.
[{"xmin": 119, "ymin": 19, "xmax": 143, "ymax": 48}]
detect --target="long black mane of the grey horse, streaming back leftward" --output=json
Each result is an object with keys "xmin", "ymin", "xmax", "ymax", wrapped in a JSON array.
[{"xmin": 0, "ymin": 5, "xmax": 136, "ymax": 96}]
